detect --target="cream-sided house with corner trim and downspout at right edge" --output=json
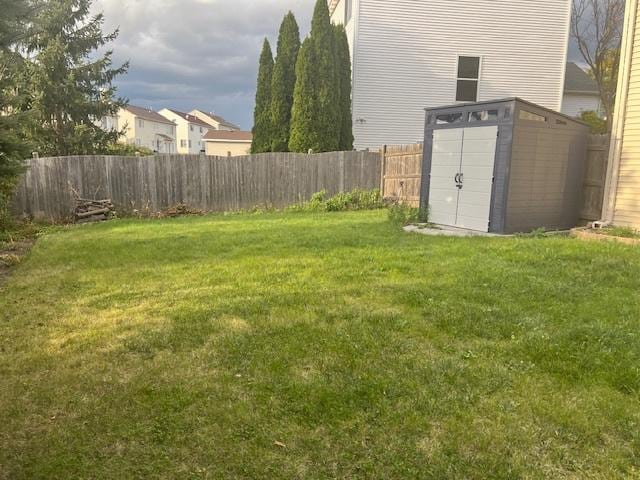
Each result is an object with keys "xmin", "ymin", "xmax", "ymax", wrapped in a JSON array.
[{"xmin": 602, "ymin": 0, "xmax": 640, "ymax": 229}]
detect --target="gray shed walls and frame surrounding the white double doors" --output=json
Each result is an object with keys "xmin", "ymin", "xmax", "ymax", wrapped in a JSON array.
[{"xmin": 420, "ymin": 99, "xmax": 589, "ymax": 233}]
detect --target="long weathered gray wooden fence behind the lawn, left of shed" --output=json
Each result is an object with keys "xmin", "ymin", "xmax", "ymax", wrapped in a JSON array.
[{"xmin": 14, "ymin": 152, "xmax": 381, "ymax": 220}]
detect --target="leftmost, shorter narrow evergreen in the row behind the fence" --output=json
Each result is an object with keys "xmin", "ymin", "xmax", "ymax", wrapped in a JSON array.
[{"xmin": 251, "ymin": 38, "xmax": 273, "ymax": 153}]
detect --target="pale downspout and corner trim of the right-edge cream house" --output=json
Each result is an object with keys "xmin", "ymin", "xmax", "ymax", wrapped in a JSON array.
[{"xmin": 594, "ymin": 0, "xmax": 638, "ymax": 226}]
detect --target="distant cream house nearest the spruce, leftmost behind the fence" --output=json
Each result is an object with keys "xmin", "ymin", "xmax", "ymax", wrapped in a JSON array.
[{"xmin": 102, "ymin": 105, "xmax": 176, "ymax": 153}]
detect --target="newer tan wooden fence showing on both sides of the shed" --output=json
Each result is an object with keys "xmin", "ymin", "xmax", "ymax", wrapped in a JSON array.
[{"xmin": 381, "ymin": 135, "xmax": 609, "ymax": 221}]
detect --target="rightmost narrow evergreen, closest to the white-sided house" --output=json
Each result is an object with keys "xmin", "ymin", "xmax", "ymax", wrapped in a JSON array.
[{"xmin": 334, "ymin": 25, "xmax": 353, "ymax": 151}]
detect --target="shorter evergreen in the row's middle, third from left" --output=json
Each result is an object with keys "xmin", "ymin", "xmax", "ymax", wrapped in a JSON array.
[{"xmin": 289, "ymin": 38, "xmax": 321, "ymax": 153}]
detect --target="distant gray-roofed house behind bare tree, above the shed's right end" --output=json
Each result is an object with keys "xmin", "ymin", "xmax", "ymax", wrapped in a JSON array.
[{"xmin": 562, "ymin": 62, "xmax": 602, "ymax": 117}]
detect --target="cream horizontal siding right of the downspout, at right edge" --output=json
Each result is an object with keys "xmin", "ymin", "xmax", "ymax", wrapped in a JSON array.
[{"xmin": 613, "ymin": 5, "xmax": 640, "ymax": 228}]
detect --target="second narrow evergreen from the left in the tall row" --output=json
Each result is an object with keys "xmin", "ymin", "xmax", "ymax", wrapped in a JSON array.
[{"xmin": 271, "ymin": 12, "xmax": 300, "ymax": 152}]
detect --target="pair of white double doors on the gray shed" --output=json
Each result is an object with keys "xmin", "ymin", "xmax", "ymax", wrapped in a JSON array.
[{"xmin": 429, "ymin": 126, "xmax": 498, "ymax": 232}]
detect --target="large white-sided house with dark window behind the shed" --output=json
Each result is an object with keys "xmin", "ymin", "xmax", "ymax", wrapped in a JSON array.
[{"xmin": 328, "ymin": 0, "xmax": 571, "ymax": 149}]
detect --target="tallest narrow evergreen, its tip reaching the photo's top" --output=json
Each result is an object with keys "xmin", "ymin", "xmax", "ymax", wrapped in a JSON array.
[{"xmin": 310, "ymin": 0, "xmax": 340, "ymax": 152}]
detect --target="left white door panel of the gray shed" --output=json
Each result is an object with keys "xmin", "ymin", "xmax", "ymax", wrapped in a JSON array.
[{"xmin": 429, "ymin": 128, "xmax": 464, "ymax": 225}]
